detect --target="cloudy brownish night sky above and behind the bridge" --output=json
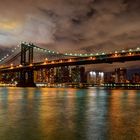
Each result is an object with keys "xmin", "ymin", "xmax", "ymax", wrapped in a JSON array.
[{"xmin": 0, "ymin": 0, "xmax": 140, "ymax": 69}]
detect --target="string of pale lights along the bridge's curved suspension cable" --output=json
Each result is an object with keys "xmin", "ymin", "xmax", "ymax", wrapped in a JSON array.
[{"xmin": 0, "ymin": 42, "xmax": 140, "ymax": 63}]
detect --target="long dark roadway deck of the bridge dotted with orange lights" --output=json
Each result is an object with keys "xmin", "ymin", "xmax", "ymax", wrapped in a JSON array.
[{"xmin": 0, "ymin": 50, "xmax": 140, "ymax": 72}]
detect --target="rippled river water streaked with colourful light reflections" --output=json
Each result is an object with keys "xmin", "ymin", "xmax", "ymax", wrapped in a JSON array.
[{"xmin": 0, "ymin": 88, "xmax": 140, "ymax": 140}]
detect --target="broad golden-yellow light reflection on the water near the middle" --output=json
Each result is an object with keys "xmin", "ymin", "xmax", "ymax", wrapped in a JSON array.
[{"xmin": 40, "ymin": 89, "xmax": 85, "ymax": 139}]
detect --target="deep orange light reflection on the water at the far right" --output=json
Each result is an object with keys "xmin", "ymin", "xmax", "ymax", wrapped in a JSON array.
[{"xmin": 108, "ymin": 90, "xmax": 140, "ymax": 140}]
